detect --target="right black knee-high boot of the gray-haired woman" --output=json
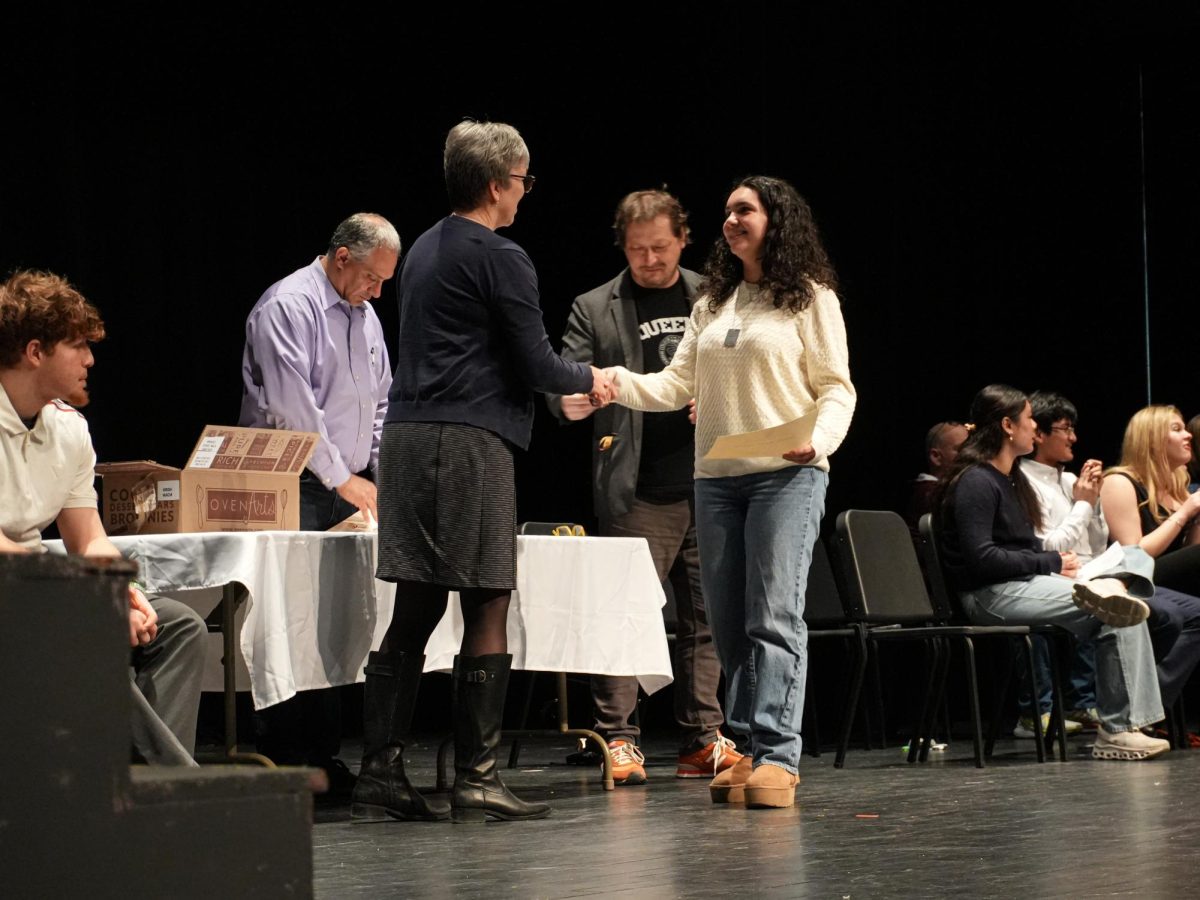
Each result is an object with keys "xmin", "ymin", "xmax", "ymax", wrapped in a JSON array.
[{"xmin": 450, "ymin": 653, "xmax": 550, "ymax": 822}]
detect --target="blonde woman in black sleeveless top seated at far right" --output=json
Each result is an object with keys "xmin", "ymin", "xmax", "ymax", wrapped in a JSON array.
[{"xmin": 1100, "ymin": 406, "xmax": 1200, "ymax": 596}]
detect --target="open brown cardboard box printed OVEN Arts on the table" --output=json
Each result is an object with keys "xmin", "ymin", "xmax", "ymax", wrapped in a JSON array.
[{"xmin": 96, "ymin": 425, "xmax": 319, "ymax": 535}]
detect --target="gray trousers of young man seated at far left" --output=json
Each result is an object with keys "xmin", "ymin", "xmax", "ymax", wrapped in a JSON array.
[{"xmin": 130, "ymin": 596, "xmax": 208, "ymax": 766}]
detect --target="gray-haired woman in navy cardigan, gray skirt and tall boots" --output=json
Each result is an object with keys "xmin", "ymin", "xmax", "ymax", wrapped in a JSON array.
[{"xmin": 352, "ymin": 120, "xmax": 612, "ymax": 822}]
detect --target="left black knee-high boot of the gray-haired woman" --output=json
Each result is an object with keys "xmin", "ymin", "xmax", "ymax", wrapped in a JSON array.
[{"xmin": 350, "ymin": 653, "xmax": 450, "ymax": 822}]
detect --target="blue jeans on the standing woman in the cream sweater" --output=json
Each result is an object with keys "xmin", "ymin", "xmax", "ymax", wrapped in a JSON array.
[{"xmin": 696, "ymin": 466, "xmax": 829, "ymax": 774}]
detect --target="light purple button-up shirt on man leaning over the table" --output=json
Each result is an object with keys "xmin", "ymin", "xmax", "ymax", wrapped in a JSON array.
[{"xmin": 239, "ymin": 257, "xmax": 391, "ymax": 488}]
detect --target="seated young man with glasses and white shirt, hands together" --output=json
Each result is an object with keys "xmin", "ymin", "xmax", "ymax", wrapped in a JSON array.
[{"xmin": 1021, "ymin": 391, "xmax": 1200, "ymax": 728}]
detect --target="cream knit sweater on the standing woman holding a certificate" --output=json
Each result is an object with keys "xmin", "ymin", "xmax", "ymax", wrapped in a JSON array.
[{"xmin": 614, "ymin": 282, "xmax": 857, "ymax": 478}]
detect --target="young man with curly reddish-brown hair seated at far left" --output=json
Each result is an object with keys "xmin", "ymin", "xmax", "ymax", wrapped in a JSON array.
[{"xmin": 0, "ymin": 271, "xmax": 206, "ymax": 766}]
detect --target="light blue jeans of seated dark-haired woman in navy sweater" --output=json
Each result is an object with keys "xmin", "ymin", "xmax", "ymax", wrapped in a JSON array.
[{"xmin": 960, "ymin": 547, "xmax": 1163, "ymax": 732}]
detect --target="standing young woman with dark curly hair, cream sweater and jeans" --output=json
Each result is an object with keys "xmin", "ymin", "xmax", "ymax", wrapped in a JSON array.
[{"xmin": 613, "ymin": 175, "xmax": 856, "ymax": 808}]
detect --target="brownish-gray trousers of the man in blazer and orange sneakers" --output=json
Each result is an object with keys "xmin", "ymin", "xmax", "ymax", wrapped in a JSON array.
[{"xmin": 592, "ymin": 499, "xmax": 725, "ymax": 751}]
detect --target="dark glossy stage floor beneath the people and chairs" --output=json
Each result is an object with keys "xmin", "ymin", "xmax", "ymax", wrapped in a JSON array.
[{"xmin": 297, "ymin": 736, "xmax": 1200, "ymax": 899}]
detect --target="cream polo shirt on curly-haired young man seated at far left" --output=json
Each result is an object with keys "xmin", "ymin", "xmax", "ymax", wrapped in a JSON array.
[{"xmin": 0, "ymin": 385, "xmax": 96, "ymax": 550}]
